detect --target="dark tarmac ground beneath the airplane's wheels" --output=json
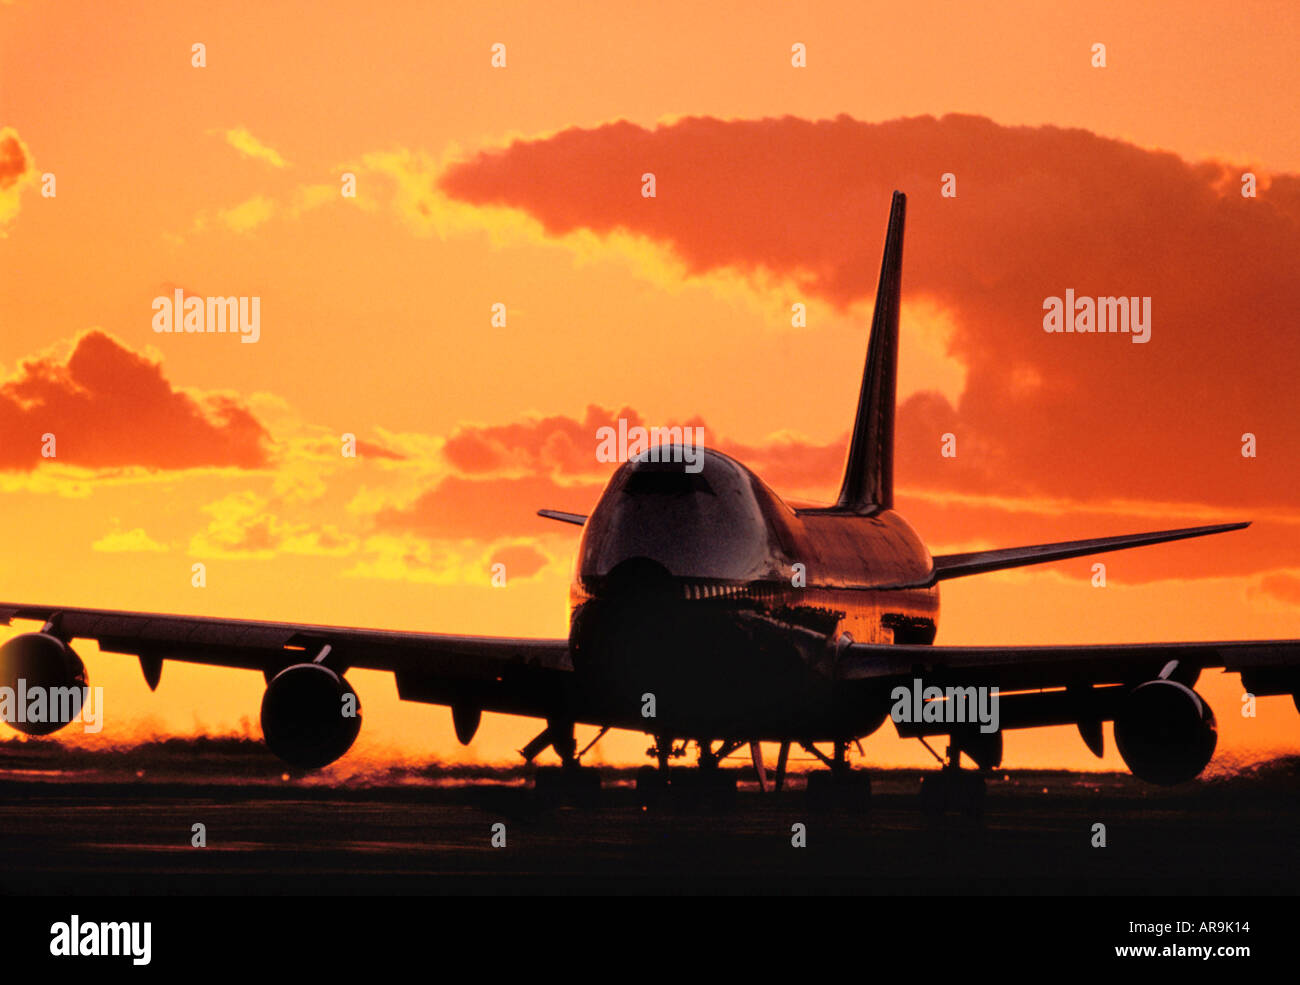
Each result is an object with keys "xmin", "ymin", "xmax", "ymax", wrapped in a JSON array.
[{"xmin": 0, "ymin": 747, "xmax": 1300, "ymax": 897}]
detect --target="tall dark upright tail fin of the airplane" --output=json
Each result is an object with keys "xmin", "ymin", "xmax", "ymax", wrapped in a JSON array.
[{"xmin": 835, "ymin": 191, "xmax": 907, "ymax": 513}]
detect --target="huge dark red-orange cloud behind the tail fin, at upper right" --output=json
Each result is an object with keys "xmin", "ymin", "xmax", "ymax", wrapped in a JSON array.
[{"xmin": 439, "ymin": 116, "xmax": 1300, "ymax": 518}]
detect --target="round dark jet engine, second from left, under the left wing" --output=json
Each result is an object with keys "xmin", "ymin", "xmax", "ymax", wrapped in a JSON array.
[{"xmin": 261, "ymin": 664, "xmax": 361, "ymax": 769}]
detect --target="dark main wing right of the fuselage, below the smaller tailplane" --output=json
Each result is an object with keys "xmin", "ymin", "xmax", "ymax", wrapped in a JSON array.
[{"xmin": 837, "ymin": 639, "xmax": 1300, "ymax": 694}]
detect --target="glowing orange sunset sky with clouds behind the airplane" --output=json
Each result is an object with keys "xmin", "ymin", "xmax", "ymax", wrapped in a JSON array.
[{"xmin": 0, "ymin": 0, "xmax": 1300, "ymax": 767}]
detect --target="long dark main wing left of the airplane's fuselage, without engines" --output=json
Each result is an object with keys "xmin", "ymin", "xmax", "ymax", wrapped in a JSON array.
[{"xmin": 0, "ymin": 603, "xmax": 573, "ymax": 717}]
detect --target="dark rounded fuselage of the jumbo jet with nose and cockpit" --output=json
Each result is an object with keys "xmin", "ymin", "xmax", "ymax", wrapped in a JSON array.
[{"xmin": 571, "ymin": 450, "xmax": 939, "ymax": 741}]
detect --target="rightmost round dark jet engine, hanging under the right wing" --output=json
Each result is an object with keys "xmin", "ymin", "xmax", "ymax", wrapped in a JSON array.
[{"xmin": 1115, "ymin": 678, "xmax": 1218, "ymax": 786}]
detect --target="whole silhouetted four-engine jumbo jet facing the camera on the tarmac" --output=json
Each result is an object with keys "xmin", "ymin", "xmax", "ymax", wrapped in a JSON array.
[{"xmin": 0, "ymin": 191, "xmax": 1300, "ymax": 811}]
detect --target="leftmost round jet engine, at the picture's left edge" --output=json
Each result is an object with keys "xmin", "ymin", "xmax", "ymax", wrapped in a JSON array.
[{"xmin": 0, "ymin": 633, "xmax": 86, "ymax": 736}]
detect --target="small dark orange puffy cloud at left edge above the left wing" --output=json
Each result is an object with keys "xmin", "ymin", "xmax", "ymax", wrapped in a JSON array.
[{"xmin": 0, "ymin": 329, "xmax": 269, "ymax": 470}]
